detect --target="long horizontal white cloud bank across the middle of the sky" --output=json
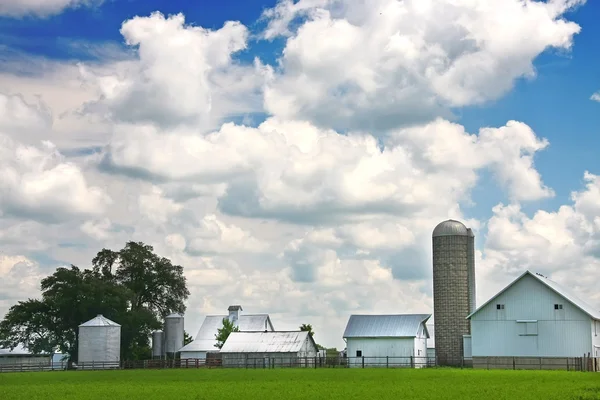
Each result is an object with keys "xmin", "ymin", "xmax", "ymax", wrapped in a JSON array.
[{"xmin": 104, "ymin": 115, "xmax": 553, "ymax": 223}]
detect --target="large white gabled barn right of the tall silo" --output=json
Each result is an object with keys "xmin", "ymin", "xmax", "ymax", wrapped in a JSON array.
[{"xmin": 467, "ymin": 271, "xmax": 600, "ymax": 367}]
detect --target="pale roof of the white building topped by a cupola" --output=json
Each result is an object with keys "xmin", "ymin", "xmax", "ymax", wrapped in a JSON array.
[{"xmin": 179, "ymin": 314, "xmax": 273, "ymax": 351}]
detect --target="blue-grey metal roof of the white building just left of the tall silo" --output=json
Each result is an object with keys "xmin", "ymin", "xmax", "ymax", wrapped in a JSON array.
[{"xmin": 343, "ymin": 314, "xmax": 431, "ymax": 338}]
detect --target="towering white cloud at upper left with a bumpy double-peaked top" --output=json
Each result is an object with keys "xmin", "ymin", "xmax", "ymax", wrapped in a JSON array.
[{"xmin": 77, "ymin": 12, "xmax": 263, "ymax": 128}]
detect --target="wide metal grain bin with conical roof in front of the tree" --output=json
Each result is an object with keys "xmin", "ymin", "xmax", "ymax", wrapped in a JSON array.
[{"xmin": 77, "ymin": 314, "xmax": 121, "ymax": 369}]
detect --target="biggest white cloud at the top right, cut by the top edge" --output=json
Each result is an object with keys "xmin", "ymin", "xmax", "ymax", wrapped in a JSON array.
[{"xmin": 265, "ymin": 0, "xmax": 585, "ymax": 131}]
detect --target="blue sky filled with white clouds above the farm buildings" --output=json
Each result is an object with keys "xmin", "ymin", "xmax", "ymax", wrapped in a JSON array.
[{"xmin": 0, "ymin": 0, "xmax": 600, "ymax": 348}]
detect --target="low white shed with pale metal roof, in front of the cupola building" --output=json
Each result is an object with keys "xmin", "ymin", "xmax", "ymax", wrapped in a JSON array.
[{"xmin": 220, "ymin": 331, "xmax": 318, "ymax": 368}]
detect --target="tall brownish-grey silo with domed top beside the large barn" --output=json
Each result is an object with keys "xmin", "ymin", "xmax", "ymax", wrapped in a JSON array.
[{"xmin": 432, "ymin": 220, "xmax": 475, "ymax": 366}]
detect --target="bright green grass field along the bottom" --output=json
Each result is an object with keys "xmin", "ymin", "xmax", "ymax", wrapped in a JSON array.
[{"xmin": 0, "ymin": 369, "xmax": 600, "ymax": 400}]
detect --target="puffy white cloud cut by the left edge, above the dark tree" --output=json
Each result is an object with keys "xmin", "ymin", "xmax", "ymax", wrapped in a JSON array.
[{"xmin": 0, "ymin": 94, "xmax": 111, "ymax": 222}]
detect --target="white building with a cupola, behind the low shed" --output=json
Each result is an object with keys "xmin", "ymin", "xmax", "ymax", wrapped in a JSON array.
[{"xmin": 179, "ymin": 306, "xmax": 274, "ymax": 359}]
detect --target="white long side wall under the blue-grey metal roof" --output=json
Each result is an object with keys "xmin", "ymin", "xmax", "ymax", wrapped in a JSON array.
[{"xmin": 347, "ymin": 338, "xmax": 414, "ymax": 367}]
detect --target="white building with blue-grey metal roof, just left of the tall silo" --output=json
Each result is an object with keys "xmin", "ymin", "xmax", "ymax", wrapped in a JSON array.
[{"xmin": 344, "ymin": 314, "xmax": 431, "ymax": 367}]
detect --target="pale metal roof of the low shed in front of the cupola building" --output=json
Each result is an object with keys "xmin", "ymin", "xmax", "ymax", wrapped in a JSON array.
[{"xmin": 221, "ymin": 331, "xmax": 316, "ymax": 353}]
